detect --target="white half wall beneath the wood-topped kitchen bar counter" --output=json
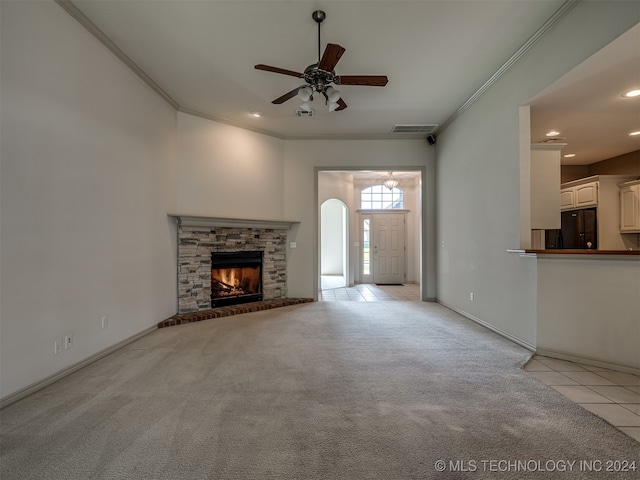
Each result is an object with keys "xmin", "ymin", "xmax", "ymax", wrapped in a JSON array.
[{"xmin": 537, "ymin": 256, "xmax": 640, "ymax": 373}]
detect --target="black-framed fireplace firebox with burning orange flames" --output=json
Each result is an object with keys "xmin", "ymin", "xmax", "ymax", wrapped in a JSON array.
[{"xmin": 211, "ymin": 251, "xmax": 263, "ymax": 308}]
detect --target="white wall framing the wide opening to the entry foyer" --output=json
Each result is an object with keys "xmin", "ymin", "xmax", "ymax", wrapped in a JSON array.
[{"xmin": 284, "ymin": 140, "xmax": 435, "ymax": 297}]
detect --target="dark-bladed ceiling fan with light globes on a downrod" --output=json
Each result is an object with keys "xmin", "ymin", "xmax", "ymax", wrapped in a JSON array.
[{"xmin": 255, "ymin": 10, "xmax": 389, "ymax": 111}]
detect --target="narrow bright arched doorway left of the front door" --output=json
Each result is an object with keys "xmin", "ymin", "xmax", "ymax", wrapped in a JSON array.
[{"xmin": 320, "ymin": 198, "xmax": 349, "ymax": 290}]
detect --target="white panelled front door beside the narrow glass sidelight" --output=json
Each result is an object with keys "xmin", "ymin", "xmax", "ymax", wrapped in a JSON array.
[{"xmin": 371, "ymin": 213, "xmax": 405, "ymax": 284}]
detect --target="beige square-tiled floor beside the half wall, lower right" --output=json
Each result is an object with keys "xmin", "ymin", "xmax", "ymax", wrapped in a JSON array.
[{"xmin": 524, "ymin": 355, "xmax": 640, "ymax": 442}]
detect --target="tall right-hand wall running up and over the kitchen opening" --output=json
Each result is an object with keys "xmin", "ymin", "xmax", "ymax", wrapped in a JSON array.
[{"xmin": 436, "ymin": 2, "xmax": 640, "ymax": 352}]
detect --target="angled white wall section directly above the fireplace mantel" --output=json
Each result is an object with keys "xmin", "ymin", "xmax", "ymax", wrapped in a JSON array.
[{"xmin": 178, "ymin": 113, "xmax": 284, "ymax": 220}]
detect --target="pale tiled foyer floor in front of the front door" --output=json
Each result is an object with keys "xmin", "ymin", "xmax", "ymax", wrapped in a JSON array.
[{"xmin": 318, "ymin": 283, "xmax": 420, "ymax": 302}]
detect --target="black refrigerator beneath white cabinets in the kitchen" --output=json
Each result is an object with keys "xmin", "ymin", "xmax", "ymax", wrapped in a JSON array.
[{"xmin": 545, "ymin": 208, "xmax": 598, "ymax": 250}]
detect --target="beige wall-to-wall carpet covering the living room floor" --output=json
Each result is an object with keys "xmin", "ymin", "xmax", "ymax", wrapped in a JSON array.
[{"xmin": 0, "ymin": 302, "xmax": 640, "ymax": 480}]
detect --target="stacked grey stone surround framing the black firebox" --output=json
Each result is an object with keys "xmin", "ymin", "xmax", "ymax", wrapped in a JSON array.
[{"xmin": 178, "ymin": 218, "xmax": 296, "ymax": 314}]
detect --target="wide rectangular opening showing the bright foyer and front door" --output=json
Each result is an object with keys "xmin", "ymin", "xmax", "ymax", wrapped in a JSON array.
[{"xmin": 315, "ymin": 166, "xmax": 424, "ymax": 301}]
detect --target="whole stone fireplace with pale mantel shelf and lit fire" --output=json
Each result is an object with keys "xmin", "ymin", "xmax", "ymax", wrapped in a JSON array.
[{"xmin": 170, "ymin": 215, "xmax": 297, "ymax": 314}]
